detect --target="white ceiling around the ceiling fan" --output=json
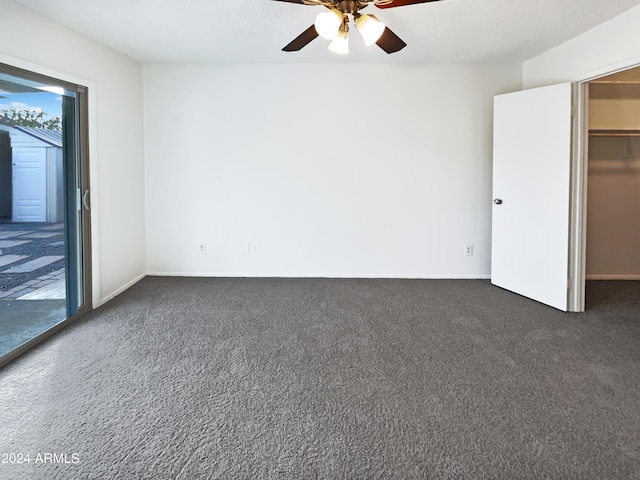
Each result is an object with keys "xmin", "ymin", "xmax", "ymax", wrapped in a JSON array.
[{"xmin": 11, "ymin": 0, "xmax": 640, "ymax": 63}]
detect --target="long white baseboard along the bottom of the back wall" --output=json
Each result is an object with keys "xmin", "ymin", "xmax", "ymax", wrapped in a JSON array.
[{"xmin": 147, "ymin": 271, "xmax": 491, "ymax": 280}]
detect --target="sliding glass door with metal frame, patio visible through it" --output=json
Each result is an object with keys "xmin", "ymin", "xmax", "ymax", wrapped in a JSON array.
[{"xmin": 0, "ymin": 64, "xmax": 91, "ymax": 363}]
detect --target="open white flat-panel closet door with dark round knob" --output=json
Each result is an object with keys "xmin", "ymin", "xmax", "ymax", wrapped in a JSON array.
[{"xmin": 491, "ymin": 83, "xmax": 572, "ymax": 311}]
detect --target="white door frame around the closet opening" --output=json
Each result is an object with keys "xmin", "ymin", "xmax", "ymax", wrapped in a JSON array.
[{"xmin": 568, "ymin": 58, "xmax": 640, "ymax": 312}]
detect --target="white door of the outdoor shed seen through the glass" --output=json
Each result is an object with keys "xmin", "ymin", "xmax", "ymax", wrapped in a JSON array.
[{"xmin": 13, "ymin": 147, "xmax": 47, "ymax": 222}]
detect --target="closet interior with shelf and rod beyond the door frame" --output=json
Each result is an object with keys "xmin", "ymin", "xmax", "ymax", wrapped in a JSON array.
[{"xmin": 585, "ymin": 67, "xmax": 640, "ymax": 309}]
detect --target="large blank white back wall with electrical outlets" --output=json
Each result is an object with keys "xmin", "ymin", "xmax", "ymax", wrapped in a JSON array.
[{"xmin": 144, "ymin": 65, "xmax": 521, "ymax": 277}]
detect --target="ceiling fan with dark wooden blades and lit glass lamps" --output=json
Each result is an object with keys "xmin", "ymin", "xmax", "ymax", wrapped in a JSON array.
[{"xmin": 276, "ymin": 0, "xmax": 440, "ymax": 54}]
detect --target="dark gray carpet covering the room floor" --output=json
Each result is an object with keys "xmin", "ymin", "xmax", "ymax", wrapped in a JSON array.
[{"xmin": 0, "ymin": 278, "xmax": 640, "ymax": 479}]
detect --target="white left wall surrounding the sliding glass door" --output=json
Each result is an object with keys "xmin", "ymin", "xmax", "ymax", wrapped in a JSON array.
[{"xmin": 0, "ymin": 0, "xmax": 145, "ymax": 304}]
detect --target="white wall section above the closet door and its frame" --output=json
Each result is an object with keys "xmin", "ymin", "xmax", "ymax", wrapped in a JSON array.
[{"xmin": 522, "ymin": 6, "xmax": 640, "ymax": 88}]
